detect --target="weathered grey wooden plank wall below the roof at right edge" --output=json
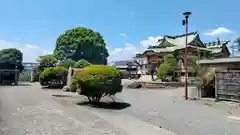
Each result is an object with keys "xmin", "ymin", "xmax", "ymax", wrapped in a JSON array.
[{"xmin": 215, "ymin": 71, "xmax": 240, "ymax": 102}]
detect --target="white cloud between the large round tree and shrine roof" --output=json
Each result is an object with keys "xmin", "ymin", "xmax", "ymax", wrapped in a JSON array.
[{"xmin": 108, "ymin": 36, "xmax": 162, "ymax": 61}]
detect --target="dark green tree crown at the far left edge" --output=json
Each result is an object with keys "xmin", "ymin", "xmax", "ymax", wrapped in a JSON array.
[{"xmin": 0, "ymin": 48, "xmax": 23, "ymax": 72}]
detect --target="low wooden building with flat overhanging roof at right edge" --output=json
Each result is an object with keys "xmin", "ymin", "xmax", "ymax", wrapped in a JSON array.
[{"xmin": 199, "ymin": 57, "xmax": 240, "ymax": 102}]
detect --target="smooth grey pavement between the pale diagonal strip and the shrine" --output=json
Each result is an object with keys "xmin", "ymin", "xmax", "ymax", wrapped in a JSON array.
[{"xmin": 118, "ymin": 88, "xmax": 240, "ymax": 135}]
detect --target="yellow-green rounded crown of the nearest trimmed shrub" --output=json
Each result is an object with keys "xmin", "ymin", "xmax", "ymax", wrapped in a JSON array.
[{"xmin": 72, "ymin": 65, "xmax": 122, "ymax": 97}]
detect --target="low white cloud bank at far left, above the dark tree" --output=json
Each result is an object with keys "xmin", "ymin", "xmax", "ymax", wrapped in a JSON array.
[{"xmin": 0, "ymin": 40, "xmax": 52, "ymax": 62}]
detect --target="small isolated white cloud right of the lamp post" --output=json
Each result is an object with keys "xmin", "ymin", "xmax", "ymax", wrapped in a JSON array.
[{"xmin": 204, "ymin": 27, "xmax": 232, "ymax": 36}]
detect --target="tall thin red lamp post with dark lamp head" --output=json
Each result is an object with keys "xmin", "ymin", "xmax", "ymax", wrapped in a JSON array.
[{"xmin": 182, "ymin": 12, "xmax": 192, "ymax": 100}]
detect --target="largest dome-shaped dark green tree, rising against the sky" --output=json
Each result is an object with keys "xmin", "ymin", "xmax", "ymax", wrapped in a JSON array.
[{"xmin": 54, "ymin": 27, "xmax": 109, "ymax": 64}]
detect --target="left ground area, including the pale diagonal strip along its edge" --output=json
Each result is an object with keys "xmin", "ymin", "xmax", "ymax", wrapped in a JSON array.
[{"xmin": 0, "ymin": 85, "xmax": 176, "ymax": 135}]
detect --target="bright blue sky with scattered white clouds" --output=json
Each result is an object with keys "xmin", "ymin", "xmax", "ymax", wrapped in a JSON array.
[{"xmin": 0, "ymin": 0, "xmax": 240, "ymax": 61}]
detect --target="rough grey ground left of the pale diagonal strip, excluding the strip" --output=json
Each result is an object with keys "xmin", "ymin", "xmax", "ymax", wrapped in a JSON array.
[{"xmin": 0, "ymin": 85, "xmax": 128, "ymax": 135}]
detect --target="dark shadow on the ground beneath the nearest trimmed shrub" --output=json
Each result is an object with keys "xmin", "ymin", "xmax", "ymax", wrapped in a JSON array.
[{"xmin": 77, "ymin": 101, "xmax": 131, "ymax": 110}]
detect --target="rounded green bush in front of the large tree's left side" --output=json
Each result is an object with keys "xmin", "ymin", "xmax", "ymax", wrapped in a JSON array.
[{"xmin": 39, "ymin": 66, "xmax": 67, "ymax": 85}]
